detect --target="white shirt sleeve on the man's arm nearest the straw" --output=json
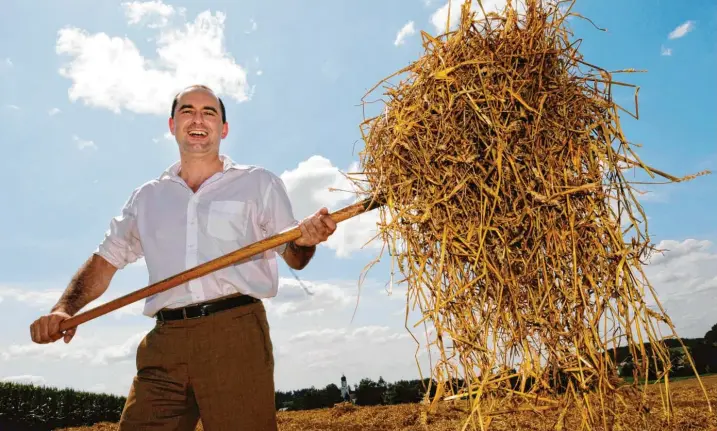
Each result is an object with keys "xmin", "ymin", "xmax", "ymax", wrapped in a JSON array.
[{"xmin": 261, "ymin": 173, "xmax": 299, "ymax": 254}]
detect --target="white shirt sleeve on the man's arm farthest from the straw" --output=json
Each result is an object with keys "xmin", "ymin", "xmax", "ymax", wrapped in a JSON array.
[{"xmin": 95, "ymin": 189, "xmax": 144, "ymax": 269}]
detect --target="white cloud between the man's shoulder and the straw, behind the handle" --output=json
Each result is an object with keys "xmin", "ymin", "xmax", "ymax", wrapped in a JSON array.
[{"xmin": 281, "ymin": 155, "xmax": 382, "ymax": 257}]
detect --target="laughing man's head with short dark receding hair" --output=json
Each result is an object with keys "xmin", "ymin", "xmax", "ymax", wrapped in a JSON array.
[{"xmin": 169, "ymin": 89, "xmax": 229, "ymax": 154}]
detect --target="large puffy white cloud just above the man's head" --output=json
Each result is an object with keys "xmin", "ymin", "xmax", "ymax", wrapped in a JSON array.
[{"xmin": 55, "ymin": 2, "xmax": 249, "ymax": 115}]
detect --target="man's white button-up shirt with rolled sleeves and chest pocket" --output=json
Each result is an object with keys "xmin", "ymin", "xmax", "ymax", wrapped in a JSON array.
[{"xmin": 95, "ymin": 155, "xmax": 298, "ymax": 317}]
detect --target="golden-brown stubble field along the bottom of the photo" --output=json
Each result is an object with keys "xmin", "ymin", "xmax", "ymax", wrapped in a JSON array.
[{"xmin": 61, "ymin": 375, "xmax": 717, "ymax": 431}]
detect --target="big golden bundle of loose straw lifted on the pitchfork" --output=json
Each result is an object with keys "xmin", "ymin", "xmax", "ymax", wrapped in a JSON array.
[{"xmin": 348, "ymin": 1, "xmax": 712, "ymax": 429}]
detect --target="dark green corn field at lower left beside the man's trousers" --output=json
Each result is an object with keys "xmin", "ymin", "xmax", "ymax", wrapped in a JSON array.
[{"xmin": 0, "ymin": 382, "xmax": 125, "ymax": 430}]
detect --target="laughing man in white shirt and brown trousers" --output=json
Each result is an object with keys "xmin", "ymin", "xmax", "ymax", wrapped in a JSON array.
[{"xmin": 30, "ymin": 82, "xmax": 336, "ymax": 431}]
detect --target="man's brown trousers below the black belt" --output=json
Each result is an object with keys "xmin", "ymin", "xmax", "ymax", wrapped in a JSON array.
[{"xmin": 119, "ymin": 302, "xmax": 277, "ymax": 431}]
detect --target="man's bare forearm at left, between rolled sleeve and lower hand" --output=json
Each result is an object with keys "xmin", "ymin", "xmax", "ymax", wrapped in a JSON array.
[{"xmin": 52, "ymin": 254, "xmax": 117, "ymax": 316}]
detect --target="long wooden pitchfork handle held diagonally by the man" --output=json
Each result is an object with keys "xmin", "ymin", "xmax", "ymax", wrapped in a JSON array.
[{"xmin": 60, "ymin": 198, "xmax": 383, "ymax": 332}]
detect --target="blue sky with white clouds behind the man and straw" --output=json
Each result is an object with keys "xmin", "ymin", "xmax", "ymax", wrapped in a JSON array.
[{"xmin": 0, "ymin": 0, "xmax": 717, "ymax": 394}]
